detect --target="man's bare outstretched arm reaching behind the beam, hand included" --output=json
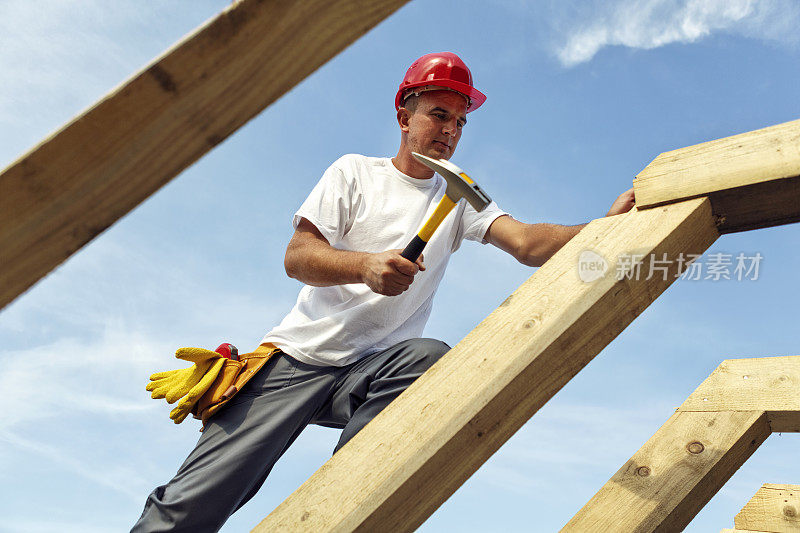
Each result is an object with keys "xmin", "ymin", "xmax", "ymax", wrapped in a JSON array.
[{"xmin": 486, "ymin": 188, "xmax": 634, "ymax": 267}]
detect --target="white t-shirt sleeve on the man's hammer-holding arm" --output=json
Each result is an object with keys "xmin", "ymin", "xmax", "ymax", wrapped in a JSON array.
[{"xmin": 292, "ymin": 161, "xmax": 354, "ymax": 245}]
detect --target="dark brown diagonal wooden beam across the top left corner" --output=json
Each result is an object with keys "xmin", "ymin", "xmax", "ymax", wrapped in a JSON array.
[{"xmin": 0, "ymin": 0, "xmax": 407, "ymax": 308}]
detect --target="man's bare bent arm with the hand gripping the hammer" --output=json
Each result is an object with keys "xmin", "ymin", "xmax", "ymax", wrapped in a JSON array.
[{"xmin": 283, "ymin": 218, "xmax": 425, "ymax": 296}]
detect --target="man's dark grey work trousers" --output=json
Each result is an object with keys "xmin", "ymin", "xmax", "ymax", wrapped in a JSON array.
[{"xmin": 131, "ymin": 339, "xmax": 450, "ymax": 533}]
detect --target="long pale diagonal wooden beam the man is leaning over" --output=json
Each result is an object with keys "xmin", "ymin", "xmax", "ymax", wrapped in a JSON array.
[{"xmin": 254, "ymin": 199, "xmax": 718, "ymax": 532}]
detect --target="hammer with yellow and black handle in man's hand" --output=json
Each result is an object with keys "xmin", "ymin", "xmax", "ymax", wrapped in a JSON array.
[{"xmin": 400, "ymin": 152, "xmax": 492, "ymax": 262}]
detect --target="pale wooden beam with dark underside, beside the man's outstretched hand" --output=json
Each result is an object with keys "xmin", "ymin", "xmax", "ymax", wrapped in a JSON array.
[{"xmin": 634, "ymin": 120, "xmax": 800, "ymax": 233}]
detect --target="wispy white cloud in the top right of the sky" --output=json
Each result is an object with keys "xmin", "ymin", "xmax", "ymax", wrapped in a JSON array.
[{"xmin": 555, "ymin": 0, "xmax": 800, "ymax": 67}]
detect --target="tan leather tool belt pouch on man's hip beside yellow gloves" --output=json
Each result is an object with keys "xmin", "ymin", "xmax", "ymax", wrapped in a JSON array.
[{"xmin": 192, "ymin": 343, "xmax": 280, "ymax": 431}]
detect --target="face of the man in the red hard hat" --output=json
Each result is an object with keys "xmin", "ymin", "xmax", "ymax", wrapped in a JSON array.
[{"xmin": 400, "ymin": 91, "xmax": 467, "ymax": 159}]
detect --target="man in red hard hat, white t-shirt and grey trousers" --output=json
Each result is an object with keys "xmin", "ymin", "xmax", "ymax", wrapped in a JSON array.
[{"xmin": 133, "ymin": 52, "xmax": 633, "ymax": 531}]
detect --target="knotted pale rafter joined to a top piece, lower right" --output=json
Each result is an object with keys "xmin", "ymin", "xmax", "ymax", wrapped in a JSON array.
[{"xmin": 562, "ymin": 356, "xmax": 800, "ymax": 532}]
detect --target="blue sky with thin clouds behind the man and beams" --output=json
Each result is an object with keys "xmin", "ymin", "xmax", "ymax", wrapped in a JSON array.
[{"xmin": 0, "ymin": 0, "xmax": 800, "ymax": 532}]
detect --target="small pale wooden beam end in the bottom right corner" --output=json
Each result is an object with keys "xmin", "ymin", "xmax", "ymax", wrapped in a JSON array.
[{"xmin": 734, "ymin": 483, "xmax": 800, "ymax": 533}]
